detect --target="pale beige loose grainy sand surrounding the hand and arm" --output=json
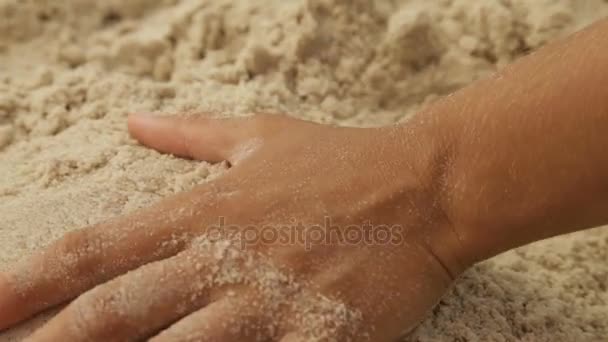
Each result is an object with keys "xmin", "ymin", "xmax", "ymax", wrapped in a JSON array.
[{"xmin": 0, "ymin": 0, "xmax": 608, "ymax": 341}]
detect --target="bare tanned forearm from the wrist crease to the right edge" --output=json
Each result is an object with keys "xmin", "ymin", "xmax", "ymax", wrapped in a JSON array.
[{"xmin": 410, "ymin": 20, "xmax": 608, "ymax": 264}]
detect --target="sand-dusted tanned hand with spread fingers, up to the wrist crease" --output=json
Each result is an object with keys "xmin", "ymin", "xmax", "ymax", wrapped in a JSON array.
[{"xmin": 0, "ymin": 115, "xmax": 463, "ymax": 341}]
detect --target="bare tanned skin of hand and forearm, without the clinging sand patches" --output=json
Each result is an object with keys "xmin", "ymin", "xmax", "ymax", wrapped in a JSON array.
[{"xmin": 0, "ymin": 21, "xmax": 608, "ymax": 341}]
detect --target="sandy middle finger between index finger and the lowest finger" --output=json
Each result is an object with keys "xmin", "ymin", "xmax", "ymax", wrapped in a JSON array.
[{"xmin": 31, "ymin": 251, "xmax": 218, "ymax": 342}]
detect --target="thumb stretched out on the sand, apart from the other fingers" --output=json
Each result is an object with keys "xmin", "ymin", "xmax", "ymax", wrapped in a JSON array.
[{"xmin": 129, "ymin": 114, "xmax": 252, "ymax": 162}]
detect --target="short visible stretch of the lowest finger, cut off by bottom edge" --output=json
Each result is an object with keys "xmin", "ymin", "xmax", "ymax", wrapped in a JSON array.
[{"xmin": 149, "ymin": 297, "xmax": 272, "ymax": 342}]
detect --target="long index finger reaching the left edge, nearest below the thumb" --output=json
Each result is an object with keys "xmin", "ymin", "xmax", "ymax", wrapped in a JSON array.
[{"xmin": 0, "ymin": 190, "xmax": 214, "ymax": 330}]
